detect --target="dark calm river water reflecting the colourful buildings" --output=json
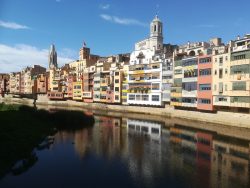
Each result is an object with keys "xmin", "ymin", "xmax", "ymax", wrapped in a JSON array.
[{"xmin": 0, "ymin": 107, "xmax": 250, "ymax": 188}]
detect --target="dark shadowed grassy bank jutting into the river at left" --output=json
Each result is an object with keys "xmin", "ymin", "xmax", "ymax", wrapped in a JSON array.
[{"xmin": 0, "ymin": 104, "xmax": 94, "ymax": 179}]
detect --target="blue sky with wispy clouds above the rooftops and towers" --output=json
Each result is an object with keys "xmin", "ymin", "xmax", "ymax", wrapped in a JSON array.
[{"xmin": 0, "ymin": 0, "xmax": 250, "ymax": 72}]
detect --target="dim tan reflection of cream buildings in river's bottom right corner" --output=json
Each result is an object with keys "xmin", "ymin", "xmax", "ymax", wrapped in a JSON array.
[{"xmin": 211, "ymin": 140, "xmax": 249, "ymax": 187}]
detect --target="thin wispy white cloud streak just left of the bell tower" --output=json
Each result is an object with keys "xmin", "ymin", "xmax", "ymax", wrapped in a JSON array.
[{"xmin": 100, "ymin": 14, "xmax": 148, "ymax": 27}]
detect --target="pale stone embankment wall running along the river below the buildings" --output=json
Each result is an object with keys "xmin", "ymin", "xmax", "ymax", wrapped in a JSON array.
[{"xmin": 0, "ymin": 94, "xmax": 250, "ymax": 128}]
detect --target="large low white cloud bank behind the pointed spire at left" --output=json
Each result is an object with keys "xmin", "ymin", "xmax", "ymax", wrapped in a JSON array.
[{"xmin": 0, "ymin": 44, "xmax": 73, "ymax": 73}]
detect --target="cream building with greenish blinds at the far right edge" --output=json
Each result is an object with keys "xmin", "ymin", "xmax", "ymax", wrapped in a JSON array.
[{"xmin": 229, "ymin": 35, "xmax": 250, "ymax": 112}]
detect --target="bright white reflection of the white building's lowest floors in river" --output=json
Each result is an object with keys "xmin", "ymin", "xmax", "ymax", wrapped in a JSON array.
[{"xmin": 127, "ymin": 119, "xmax": 161, "ymax": 140}]
